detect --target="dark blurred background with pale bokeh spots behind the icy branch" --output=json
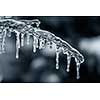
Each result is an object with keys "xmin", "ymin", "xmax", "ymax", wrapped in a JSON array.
[{"xmin": 0, "ymin": 16, "xmax": 100, "ymax": 83}]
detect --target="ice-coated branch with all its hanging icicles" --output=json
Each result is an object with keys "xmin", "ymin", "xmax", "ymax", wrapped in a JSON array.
[{"xmin": 0, "ymin": 16, "xmax": 84, "ymax": 79}]
